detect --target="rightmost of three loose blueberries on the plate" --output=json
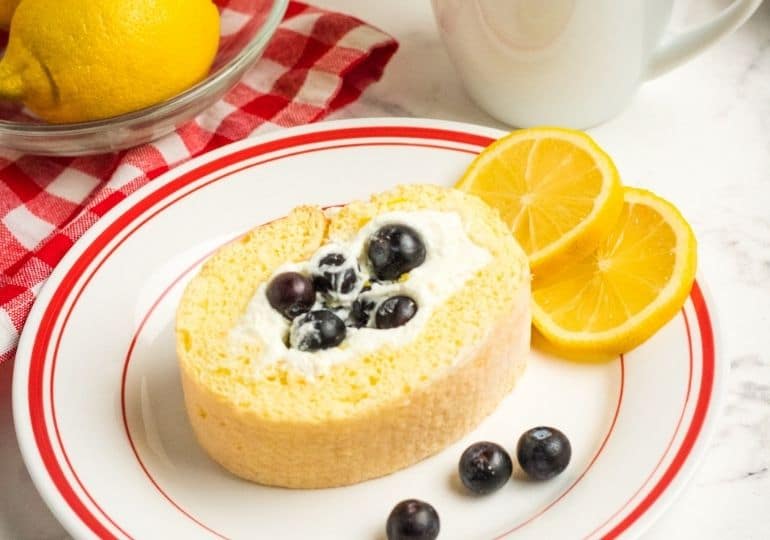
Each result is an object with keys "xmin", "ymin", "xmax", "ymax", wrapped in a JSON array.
[{"xmin": 516, "ymin": 427, "xmax": 572, "ymax": 480}]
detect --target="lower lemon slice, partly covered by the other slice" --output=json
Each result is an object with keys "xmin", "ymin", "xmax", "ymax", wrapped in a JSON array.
[{"xmin": 532, "ymin": 188, "xmax": 697, "ymax": 354}]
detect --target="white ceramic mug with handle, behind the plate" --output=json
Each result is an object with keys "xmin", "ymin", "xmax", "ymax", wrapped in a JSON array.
[{"xmin": 432, "ymin": 0, "xmax": 762, "ymax": 128}]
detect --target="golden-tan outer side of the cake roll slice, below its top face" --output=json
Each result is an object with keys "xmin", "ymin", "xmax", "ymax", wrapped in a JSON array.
[{"xmin": 182, "ymin": 289, "xmax": 530, "ymax": 488}]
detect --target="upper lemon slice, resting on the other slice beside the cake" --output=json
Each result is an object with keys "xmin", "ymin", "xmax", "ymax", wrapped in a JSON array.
[{"xmin": 455, "ymin": 127, "xmax": 623, "ymax": 274}]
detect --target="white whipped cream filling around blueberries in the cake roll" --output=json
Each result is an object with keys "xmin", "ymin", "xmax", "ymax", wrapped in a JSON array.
[{"xmin": 230, "ymin": 210, "xmax": 491, "ymax": 380}]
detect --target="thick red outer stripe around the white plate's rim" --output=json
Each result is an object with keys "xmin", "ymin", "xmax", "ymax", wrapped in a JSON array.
[{"xmin": 28, "ymin": 126, "xmax": 714, "ymax": 538}]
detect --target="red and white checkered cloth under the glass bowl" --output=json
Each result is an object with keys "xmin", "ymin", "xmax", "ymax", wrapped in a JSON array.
[{"xmin": 0, "ymin": 0, "xmax": 397, "ymax": 362}]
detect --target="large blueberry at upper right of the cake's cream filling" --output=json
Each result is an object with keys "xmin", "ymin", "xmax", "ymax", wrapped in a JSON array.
[{"xmin": 367, "ymin": 225, "xmax": 425, "ymax": 281}]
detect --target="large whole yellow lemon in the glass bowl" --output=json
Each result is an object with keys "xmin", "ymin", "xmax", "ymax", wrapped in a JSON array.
[{"xmin": 0, "ymin": 0, "xmax": 219, "ymax": 123}]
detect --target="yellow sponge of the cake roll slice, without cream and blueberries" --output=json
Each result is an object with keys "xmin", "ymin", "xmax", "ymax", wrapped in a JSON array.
[{"xmin": 177, "ymin": 186, "xmax": 530, "ymax": 488}]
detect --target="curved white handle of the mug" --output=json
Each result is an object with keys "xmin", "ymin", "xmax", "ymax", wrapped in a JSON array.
[{"xmin": 645, "ymin": 0, "xmax": 762, "ymax": 80}]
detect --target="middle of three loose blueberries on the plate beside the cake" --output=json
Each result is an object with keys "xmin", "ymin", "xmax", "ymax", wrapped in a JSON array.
[{"xmin": 458, "ymin": 441, "xmax": 513, "ymax": 495}]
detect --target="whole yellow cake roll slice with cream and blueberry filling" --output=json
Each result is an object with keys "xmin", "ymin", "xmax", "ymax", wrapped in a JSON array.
[{"xmin": 176, "ymin": 185, "xmax": 530, "ymax": 488}]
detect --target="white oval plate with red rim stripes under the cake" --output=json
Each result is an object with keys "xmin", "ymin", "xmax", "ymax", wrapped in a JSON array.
[{"xmin": 13, "ymin": 119, "xmax": 726, "ymax": 540}]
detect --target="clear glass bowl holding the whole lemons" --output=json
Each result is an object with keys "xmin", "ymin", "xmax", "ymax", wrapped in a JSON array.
[{"xmin": 0, "ymin": 0, "xmax": 289, "ymax": 156}]
